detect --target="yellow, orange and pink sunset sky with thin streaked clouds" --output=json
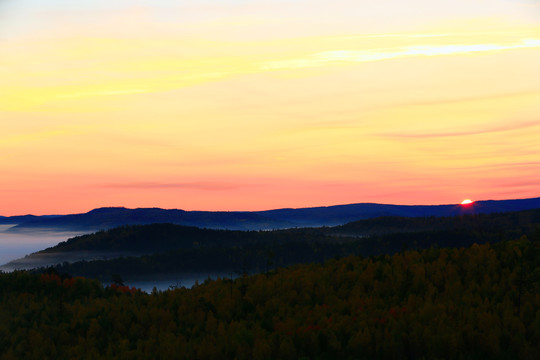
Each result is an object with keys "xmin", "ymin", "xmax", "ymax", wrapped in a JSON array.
[{"xmin": 0, "ymin": 0, "xmax": 540, "ymax": 216}]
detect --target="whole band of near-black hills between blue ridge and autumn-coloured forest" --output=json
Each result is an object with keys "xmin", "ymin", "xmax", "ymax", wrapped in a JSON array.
[{"xmin": 27, "ymin": 209, "xmax": 540, "ymax": 281}]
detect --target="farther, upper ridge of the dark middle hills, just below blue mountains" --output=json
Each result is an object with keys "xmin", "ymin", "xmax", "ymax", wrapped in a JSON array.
[{"xmin": 30, "ymin": 209, "xmax": 540, "ymax": 253}]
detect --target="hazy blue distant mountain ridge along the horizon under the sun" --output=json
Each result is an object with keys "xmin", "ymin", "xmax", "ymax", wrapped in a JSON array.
[{"xmin": 4, "ymin": 198, "xmax": 540, "ymax": 231}]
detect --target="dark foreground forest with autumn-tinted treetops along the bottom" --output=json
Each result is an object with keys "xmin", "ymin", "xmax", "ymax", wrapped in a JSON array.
[{"xmin": 0, "ymin": 235, "xmax": 540, "ymax": 360}]
